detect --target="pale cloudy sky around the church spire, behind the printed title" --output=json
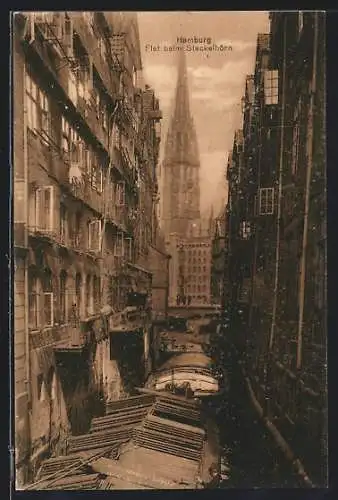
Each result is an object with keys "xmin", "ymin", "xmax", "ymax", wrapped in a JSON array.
[{"xmin": 138, "ymin": 11, "xmax": 269, "ymax": 215}]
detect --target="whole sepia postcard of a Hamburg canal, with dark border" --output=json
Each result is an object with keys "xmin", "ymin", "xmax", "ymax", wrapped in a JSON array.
[{"xmin": 11, "ymin": 11, "xmax": 328, "ymax": 490}]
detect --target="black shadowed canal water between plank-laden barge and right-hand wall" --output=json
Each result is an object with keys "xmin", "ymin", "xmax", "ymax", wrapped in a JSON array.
[{"xmin": 206, "ymin": 354, "xmax": 301, "ymax": 489}]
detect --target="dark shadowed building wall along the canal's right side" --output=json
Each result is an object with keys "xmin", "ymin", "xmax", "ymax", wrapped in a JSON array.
[{"xmin": 227, "ymin": 11, "xmax": 327, "ymax": 485}]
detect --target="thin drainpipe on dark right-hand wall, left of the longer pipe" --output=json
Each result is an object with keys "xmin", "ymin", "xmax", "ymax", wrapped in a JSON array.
[{"xmin": 269, "ymin": 16, "xmax": 287, "ymax": 355}]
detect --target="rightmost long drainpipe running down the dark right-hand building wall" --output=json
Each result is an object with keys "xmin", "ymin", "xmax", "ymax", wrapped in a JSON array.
[{"xmin": 296, "ymin": 13, "xmax": 318, "ymax": 370}]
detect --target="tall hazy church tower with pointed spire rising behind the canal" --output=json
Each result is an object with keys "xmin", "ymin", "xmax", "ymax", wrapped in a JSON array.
[{"xmin": 163, "ymin": 49, "xmax": 200, "ymax": 238}]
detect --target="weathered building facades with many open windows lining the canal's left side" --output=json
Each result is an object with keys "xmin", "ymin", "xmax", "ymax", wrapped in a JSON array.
[{"xmin": 13, "ymin": 12, "xmax": 161, "ymax": 482}]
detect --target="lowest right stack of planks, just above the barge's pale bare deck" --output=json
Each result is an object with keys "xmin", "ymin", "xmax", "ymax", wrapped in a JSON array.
[{"xmin": 133, "ymin": 415, "xmax": 205, "ymax": 462}]
